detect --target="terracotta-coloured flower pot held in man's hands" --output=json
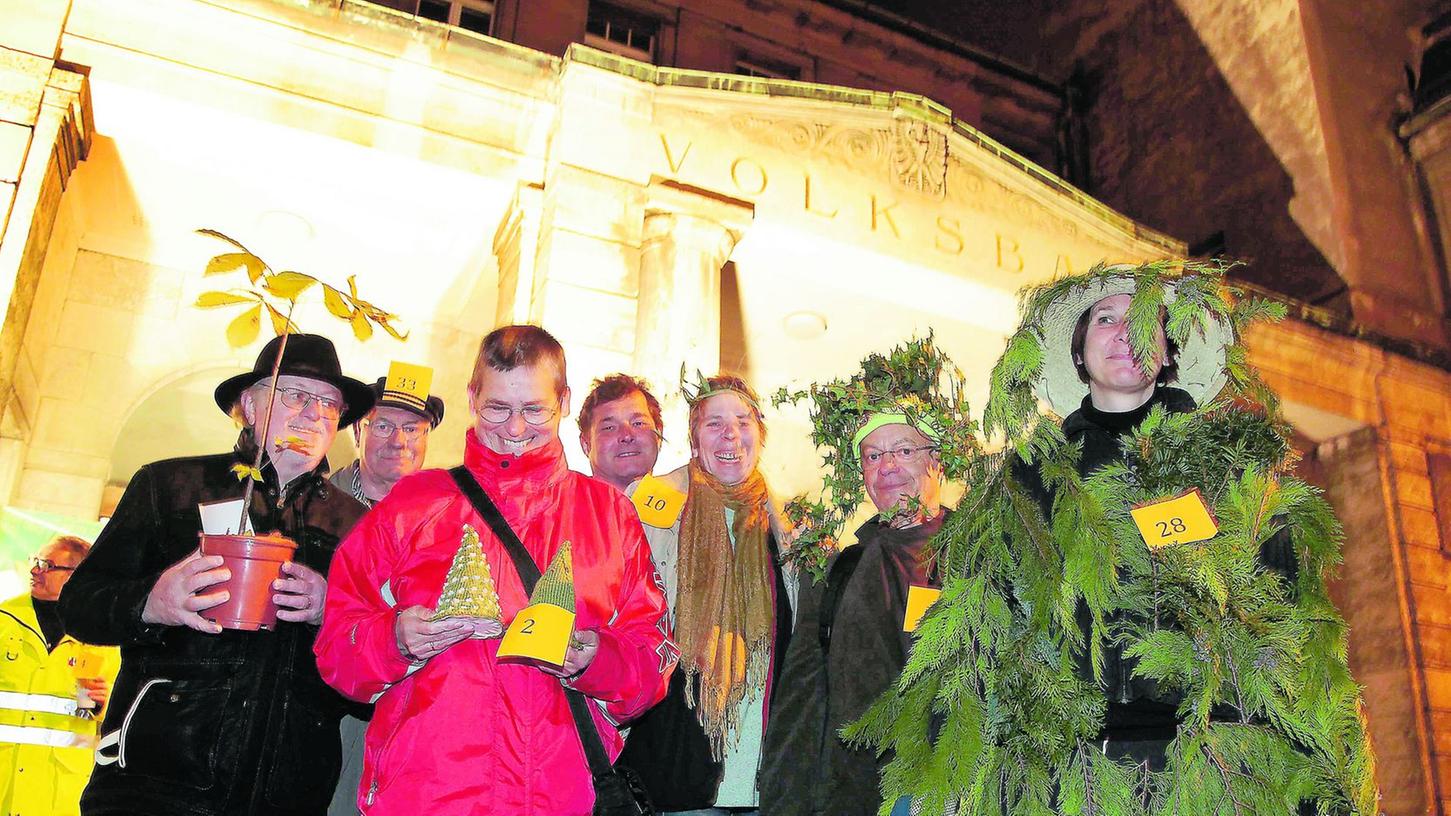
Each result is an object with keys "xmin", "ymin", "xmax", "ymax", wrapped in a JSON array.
[{"xmin": 200, "ymin": 533, "xmax": 297, "ymax": 632}]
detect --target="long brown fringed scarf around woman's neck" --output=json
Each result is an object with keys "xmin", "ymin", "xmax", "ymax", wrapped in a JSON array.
[{"xmin": 675, "ymin": 462, "xmax": 775, "ymax": 761}]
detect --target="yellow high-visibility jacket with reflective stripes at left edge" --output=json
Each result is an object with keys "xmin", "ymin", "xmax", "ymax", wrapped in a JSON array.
[{"xmin": 0, "ymin": 594, "xmax": 120, "ymax": 816}]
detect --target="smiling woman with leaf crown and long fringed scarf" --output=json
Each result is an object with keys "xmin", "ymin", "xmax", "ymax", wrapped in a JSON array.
[{"xmin": 620, "ymin": 369, "xmax": 794, "ymax": 816}]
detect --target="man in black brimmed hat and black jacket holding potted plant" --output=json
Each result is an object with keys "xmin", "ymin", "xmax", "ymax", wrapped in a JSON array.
[{"xmin": 61, "ymin": 334, "xmax": 374, "ymax": 816}]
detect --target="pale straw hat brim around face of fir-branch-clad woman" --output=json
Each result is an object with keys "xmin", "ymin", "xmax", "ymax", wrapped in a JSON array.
[{"xmin": 1033, "ymin": 270, "xmax": 1233, "ymax": 417}]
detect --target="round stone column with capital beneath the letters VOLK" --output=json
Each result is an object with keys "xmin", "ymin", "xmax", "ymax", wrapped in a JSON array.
[{"xmin": 634, "ymin": 179, "xmax": 755, "ymax": 469}]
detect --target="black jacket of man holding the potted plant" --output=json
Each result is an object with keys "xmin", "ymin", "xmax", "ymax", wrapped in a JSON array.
[{"xmin": 61, "ymin": 443, "xmax": 364, "ymax": 816}]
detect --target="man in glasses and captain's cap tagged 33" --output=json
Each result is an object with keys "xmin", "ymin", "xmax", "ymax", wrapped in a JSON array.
[{"xmin": 332, "ymin": 378, "xmax": 444, "ymax": 507}]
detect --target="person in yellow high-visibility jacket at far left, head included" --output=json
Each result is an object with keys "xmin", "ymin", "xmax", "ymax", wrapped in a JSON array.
[{"xmin": 0, "ymin": 536, "xmax": 120, "ymax": 816}]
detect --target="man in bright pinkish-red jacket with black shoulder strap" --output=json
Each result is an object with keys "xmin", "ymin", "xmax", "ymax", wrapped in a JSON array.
[{"xmin": 316, "ymin": 325, "xmax": 676, "ymax": 816}]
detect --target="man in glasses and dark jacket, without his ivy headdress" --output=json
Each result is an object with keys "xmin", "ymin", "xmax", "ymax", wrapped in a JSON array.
[{"xmin": 760, "ymin": 414, "xmax": 946, "ymax": 816}]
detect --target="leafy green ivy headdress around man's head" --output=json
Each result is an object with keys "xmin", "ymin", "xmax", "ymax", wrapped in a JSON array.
[{"xmin": 772, "ymin": 332, "xmax": 981, "ymax": 581}]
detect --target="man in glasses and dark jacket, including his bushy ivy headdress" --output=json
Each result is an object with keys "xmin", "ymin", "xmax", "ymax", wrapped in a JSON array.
[{"xmin": 760, "ymin": 338, "xmax": 975, "ymax": 816}]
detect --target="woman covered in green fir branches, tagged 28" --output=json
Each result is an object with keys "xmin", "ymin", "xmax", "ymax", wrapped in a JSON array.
[{"xmin": 847, "ymin": 261, "xmax": 1377, "ymax": 816}]
